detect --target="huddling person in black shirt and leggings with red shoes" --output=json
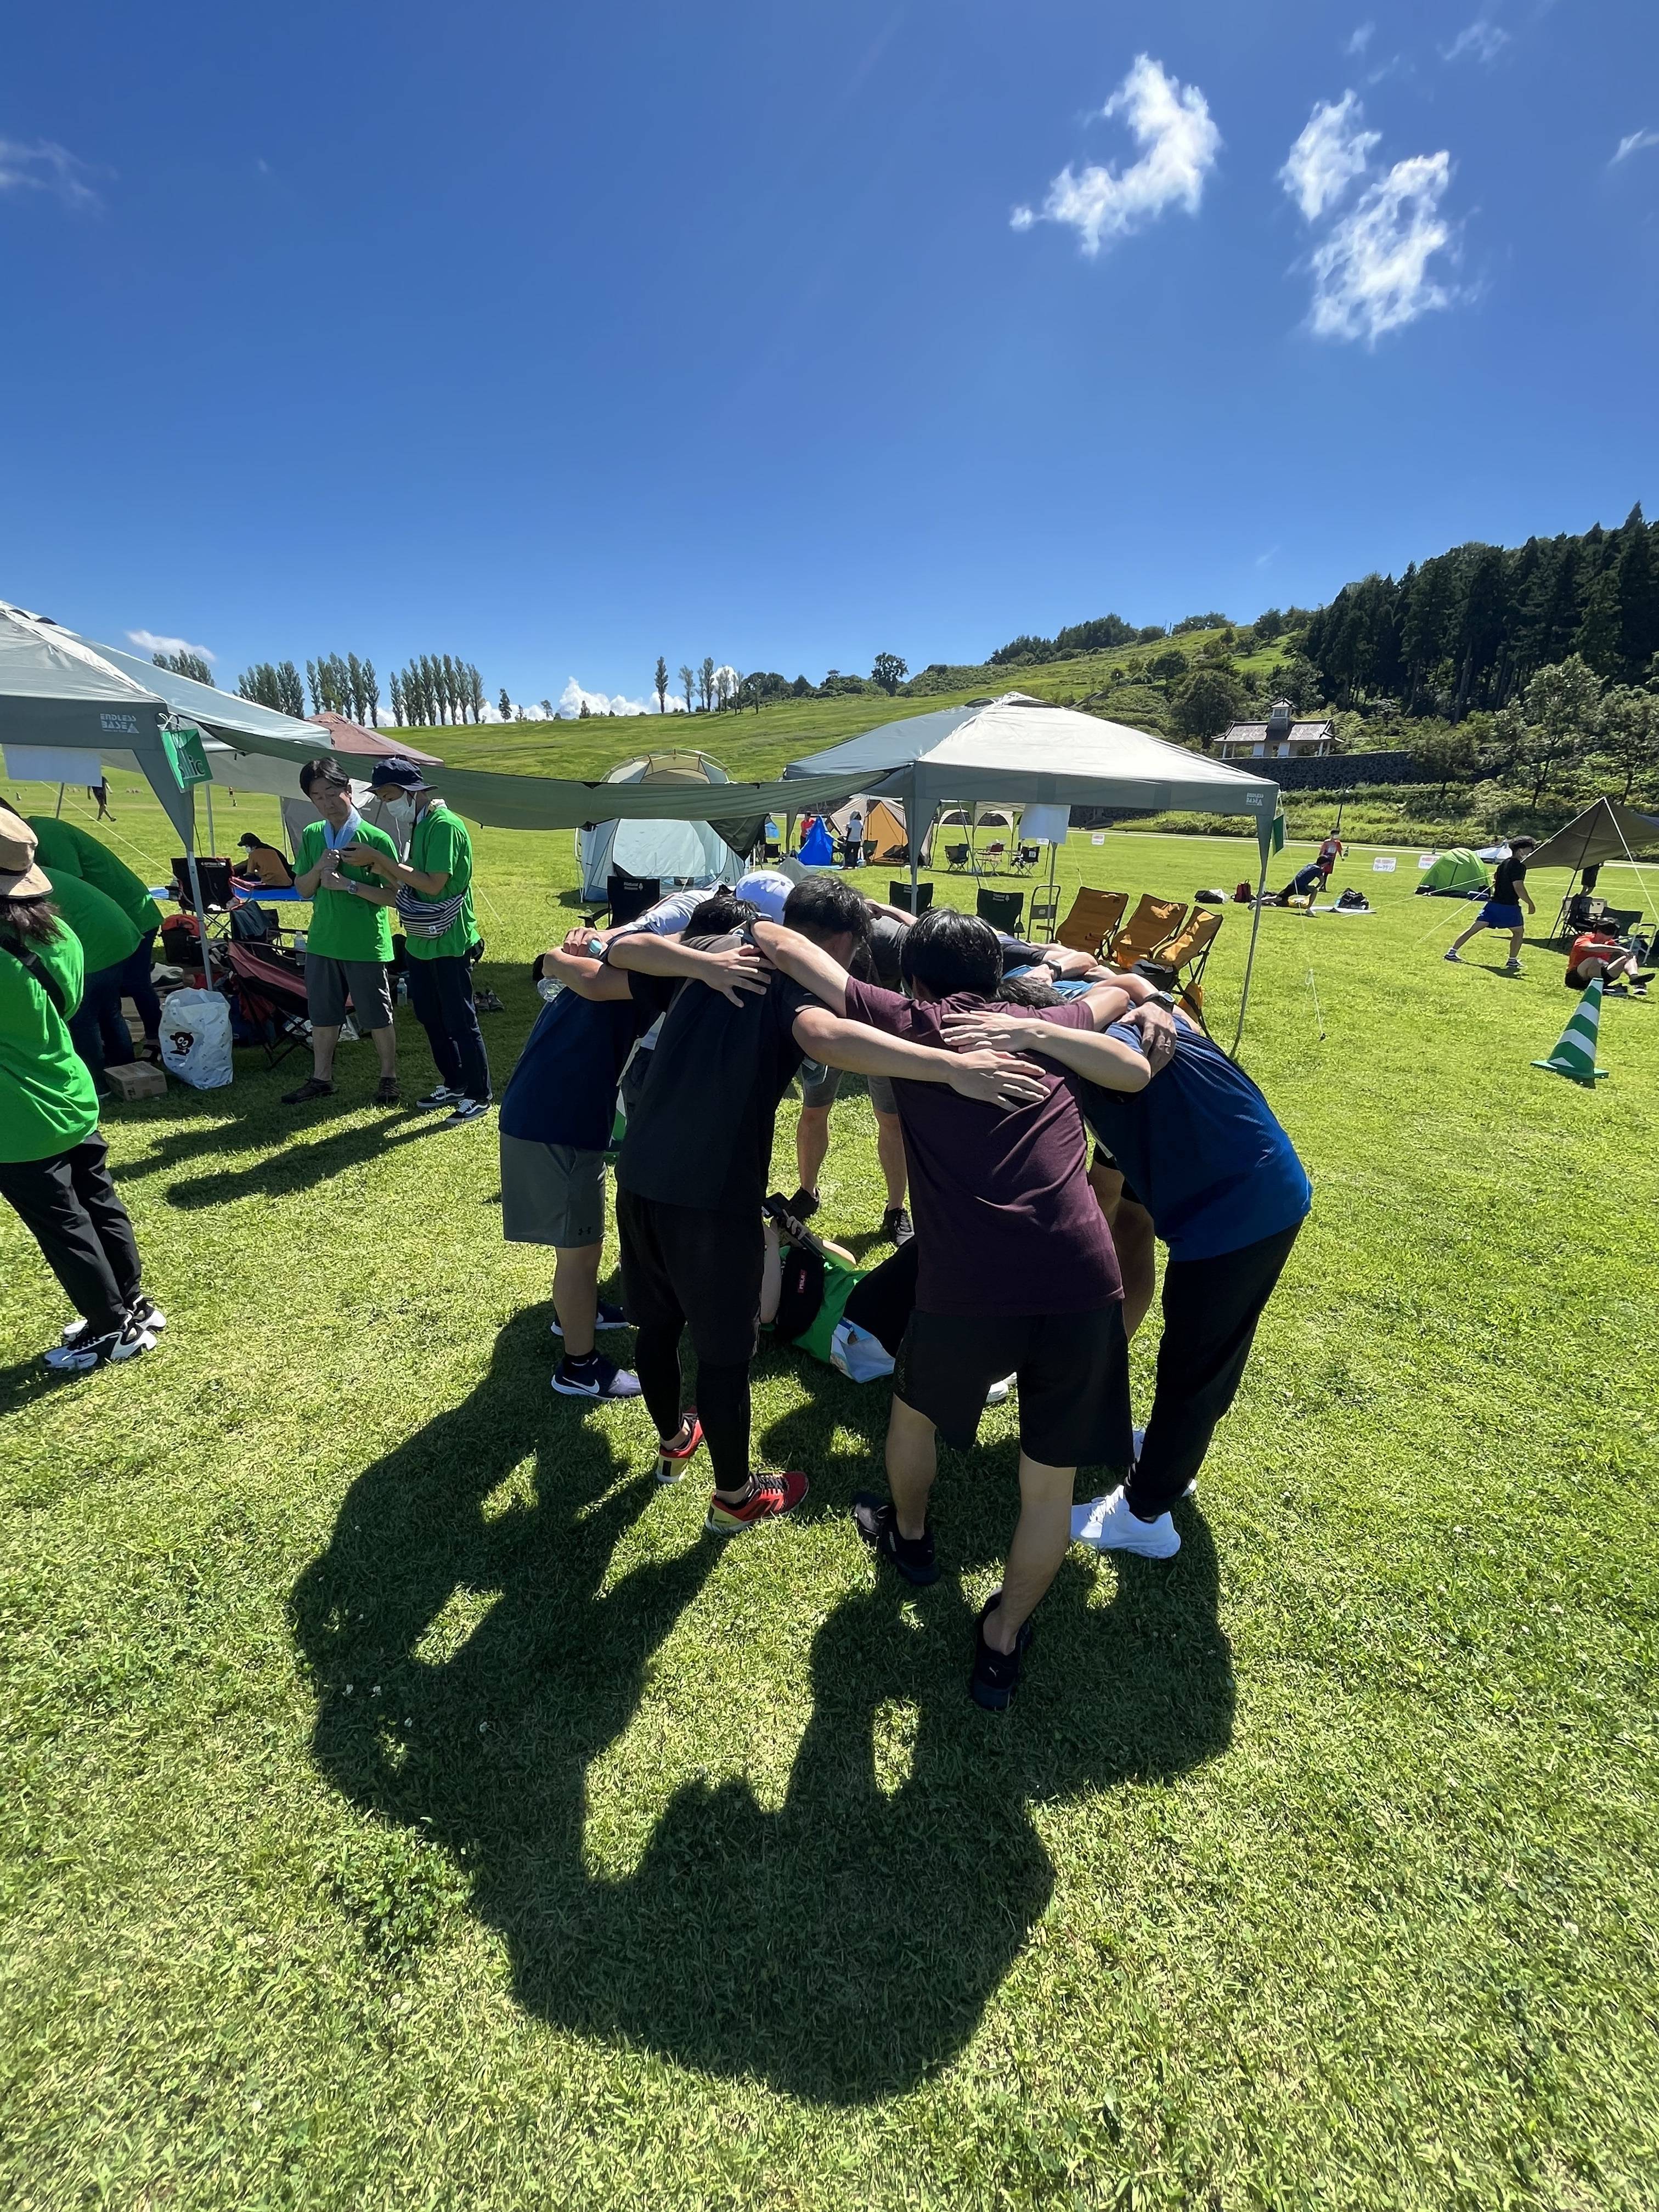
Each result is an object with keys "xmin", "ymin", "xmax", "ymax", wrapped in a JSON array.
[{"xmin": 579, "ymin": 876, "xmax": 1040, "ymax": 1535}]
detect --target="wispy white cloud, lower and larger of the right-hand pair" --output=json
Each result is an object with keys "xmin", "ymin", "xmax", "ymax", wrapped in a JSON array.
[{"xmin": 1310, "ymin": 153, "xmax": 1453, "ymax": 345}]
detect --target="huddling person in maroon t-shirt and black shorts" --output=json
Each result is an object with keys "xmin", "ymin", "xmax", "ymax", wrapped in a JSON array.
[{"xmin": 754, "ymin": 907, "xmax": 1172, "ymax": 1712}]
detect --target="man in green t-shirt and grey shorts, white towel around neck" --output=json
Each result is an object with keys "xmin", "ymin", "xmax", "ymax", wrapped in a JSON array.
[{"xmin": 283, "ymin": 759, "xmax": 398, "ymax": 1106}]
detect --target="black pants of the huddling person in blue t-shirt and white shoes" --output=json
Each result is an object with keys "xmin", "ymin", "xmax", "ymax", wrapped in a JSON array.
[{"xmin": 1128, "ymin": 1221, "xmax": 1301, "ymax": 1520}]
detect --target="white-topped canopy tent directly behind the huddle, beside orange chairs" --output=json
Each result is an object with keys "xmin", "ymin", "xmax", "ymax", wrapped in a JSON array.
[{"xmin": 783, "ymin": 692, "xmax": 1278, "ymax": 1051}]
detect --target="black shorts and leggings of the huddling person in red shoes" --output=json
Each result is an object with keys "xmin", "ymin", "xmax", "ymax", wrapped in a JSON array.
[{"xmin": 617, "ymin": 1188, "xmax": 765, "ymax": 1491}]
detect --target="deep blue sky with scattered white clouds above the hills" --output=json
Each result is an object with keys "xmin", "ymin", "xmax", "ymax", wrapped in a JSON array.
[{"xmin": 0, "ymin": 0, "xmax": 1659, "ymax": 701}]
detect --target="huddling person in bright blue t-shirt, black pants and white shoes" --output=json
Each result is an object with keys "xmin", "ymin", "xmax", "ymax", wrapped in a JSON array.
[{"xmin": 947, "ymin": 975, "xmax": 1312, "ymax": 1560}]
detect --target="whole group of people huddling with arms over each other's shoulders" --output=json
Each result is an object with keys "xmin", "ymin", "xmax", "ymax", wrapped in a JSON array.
[{"xmin": 500, "ymin": 870, "xmax": 1310, "ymax": 1710}]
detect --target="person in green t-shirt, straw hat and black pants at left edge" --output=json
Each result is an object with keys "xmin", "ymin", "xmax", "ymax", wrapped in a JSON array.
[{"xmin": 0, "ymin": 805, "xmax": 166, "ymax": 1374}]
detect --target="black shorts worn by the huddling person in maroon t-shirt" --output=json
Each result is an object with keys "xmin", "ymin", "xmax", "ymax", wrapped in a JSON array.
[{"xmin": 894, "ymin": 1303, "xmax": 1135, "ymax": 1469}]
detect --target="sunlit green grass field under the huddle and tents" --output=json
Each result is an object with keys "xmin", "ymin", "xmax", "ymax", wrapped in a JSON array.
[{"xmin": 0, "ymin": 774, "xmax": 1659, "ymax": 2212}]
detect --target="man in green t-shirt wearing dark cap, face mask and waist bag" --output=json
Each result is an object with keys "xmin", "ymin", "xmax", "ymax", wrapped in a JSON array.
[{"xmin": 345, "ymin": 754, "xmax": 489, "ymax": 1128}]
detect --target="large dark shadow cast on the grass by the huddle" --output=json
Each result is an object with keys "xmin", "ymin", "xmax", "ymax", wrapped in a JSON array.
[{"xmin": 292, "ymin": 1310, "xmax": 1232, "ymax": 2101}]
